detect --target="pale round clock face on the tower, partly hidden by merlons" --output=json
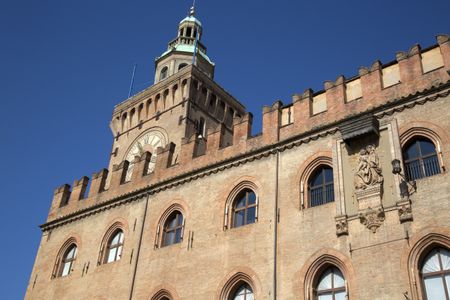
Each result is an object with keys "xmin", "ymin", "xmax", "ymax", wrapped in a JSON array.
[{"xmin": 125, "ymin": 131, "xmax": 166, "ymax": 181}]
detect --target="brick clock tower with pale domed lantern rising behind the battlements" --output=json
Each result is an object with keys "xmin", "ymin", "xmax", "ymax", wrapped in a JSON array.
[{"xmin": 107, "ymin": 8, "xmax": 245, "ymax": 184}]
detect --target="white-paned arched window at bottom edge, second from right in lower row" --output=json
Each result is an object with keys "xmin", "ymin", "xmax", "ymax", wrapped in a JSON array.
[{"xmin": 315, "ymin": 267, "xmax": 347, "ymax": 300}]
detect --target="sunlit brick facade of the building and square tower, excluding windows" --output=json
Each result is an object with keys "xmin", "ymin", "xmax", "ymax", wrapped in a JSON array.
[{"xmin": 25, "ymin": 11, "xmax": 450, "ymax": 300}]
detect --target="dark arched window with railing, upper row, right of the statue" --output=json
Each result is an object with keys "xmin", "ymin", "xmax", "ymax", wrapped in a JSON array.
[{"xmin": 403, "ymin": 137, "xmax": 441, "ymax": 180}]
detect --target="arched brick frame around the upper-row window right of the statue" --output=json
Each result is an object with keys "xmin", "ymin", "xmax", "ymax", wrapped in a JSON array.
[{"xmin": 400, "ymin": 126, "xmax": 446, "ymax": 178}]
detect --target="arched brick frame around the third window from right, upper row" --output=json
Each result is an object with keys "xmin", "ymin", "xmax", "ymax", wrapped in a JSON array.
[{"xmin": 223, "ymin": 180, "xmax": 259, "ymax": 230}]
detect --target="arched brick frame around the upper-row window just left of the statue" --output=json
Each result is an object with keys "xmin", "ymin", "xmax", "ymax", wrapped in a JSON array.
[{"xmin": 299, "ymin": 155, "xmax": 336, "ymax": 210}]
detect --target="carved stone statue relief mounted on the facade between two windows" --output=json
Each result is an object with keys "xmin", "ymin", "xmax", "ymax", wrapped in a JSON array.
[{"xmin": 355, "ymin": 145, "xmax": 383, "ymax": 190}]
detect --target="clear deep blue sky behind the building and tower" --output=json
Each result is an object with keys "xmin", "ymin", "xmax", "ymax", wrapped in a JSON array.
[{"xmin": 0, "ymin": 0, "xmax": 450, "ymax": 300}]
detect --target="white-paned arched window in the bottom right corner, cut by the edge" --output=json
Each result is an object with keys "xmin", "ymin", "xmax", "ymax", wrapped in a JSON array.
[{"xmin": 420, "ymin": 248, "xmax": 450, "ymax": 300}]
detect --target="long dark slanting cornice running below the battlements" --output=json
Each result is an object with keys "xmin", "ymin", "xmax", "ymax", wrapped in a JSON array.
[{"xmin": 40, "ymin": 81, "xmax": 450, "ymax": 231}]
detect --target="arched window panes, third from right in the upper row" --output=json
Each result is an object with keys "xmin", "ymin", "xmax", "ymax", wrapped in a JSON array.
[{"xmin": 232, "ymin": 189, "xmax": 258, "ymax": 227}]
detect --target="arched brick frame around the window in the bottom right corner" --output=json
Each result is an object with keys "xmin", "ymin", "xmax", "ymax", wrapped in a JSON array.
[{"xmin": 406, "ymin": 228, "xmax": 450, "ymax": 299}]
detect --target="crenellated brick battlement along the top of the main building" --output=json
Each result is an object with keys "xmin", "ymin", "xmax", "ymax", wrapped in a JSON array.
[{"xmin": 43, "ymin": 35, "xmax": 450, "ymax": 222}]
